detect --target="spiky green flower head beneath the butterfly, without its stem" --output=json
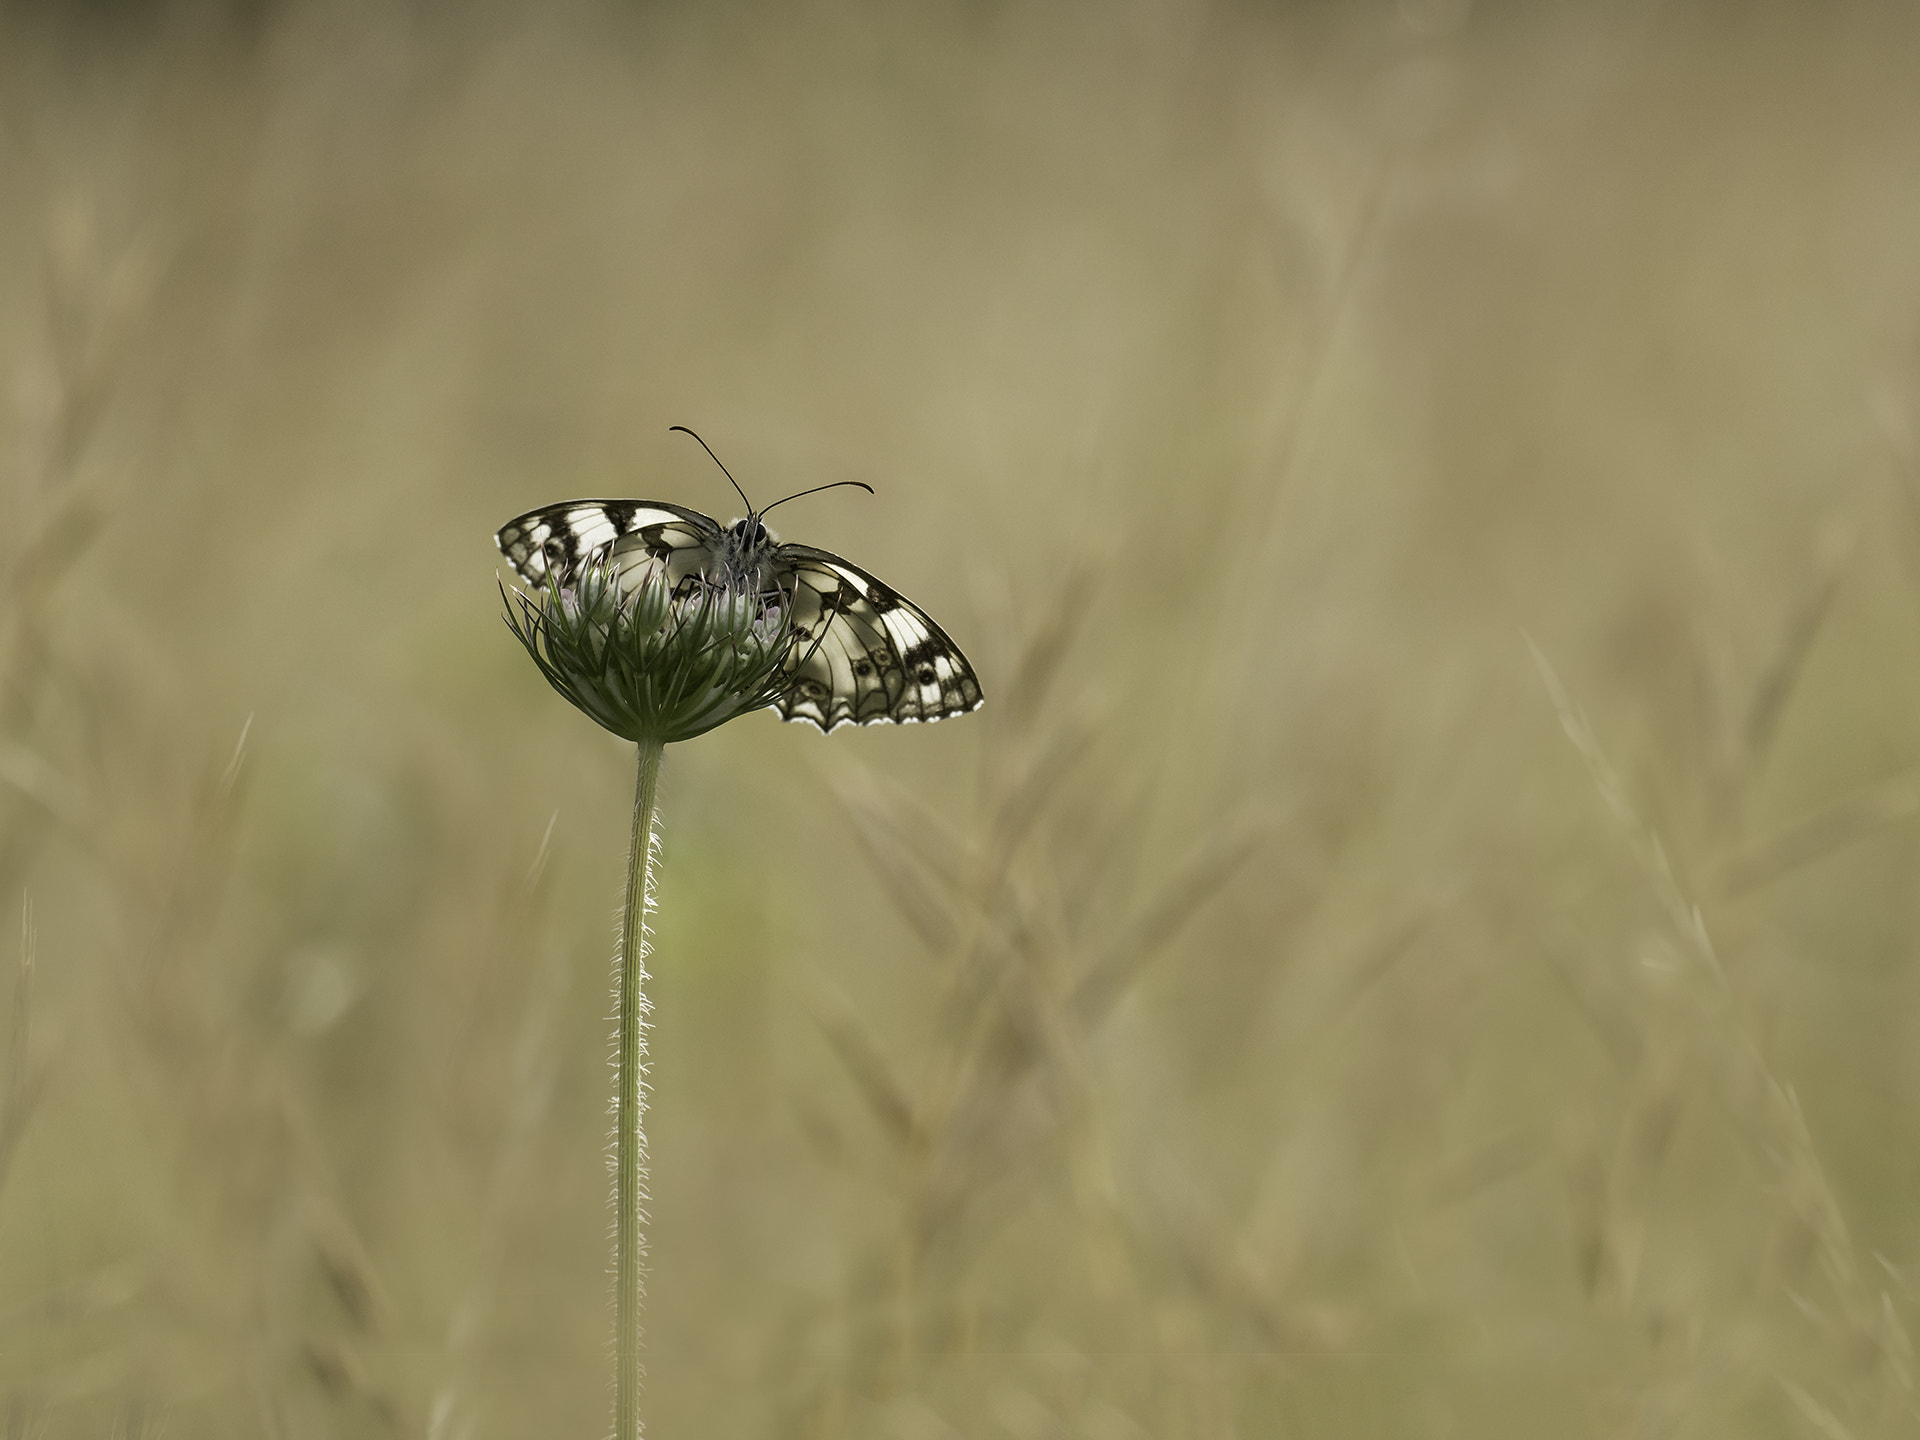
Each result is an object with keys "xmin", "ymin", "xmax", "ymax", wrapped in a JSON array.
[{"xmin": 503, "ymin": 551, "xmax": 793, "ymax": 745}]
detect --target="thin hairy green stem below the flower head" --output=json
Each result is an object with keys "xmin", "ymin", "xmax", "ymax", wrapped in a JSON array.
[{"xmin": 612, "ymin": 739, "xmax": 666, "ymax": 1440}]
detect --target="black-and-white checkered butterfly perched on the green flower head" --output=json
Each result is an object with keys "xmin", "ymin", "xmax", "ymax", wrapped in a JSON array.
[{"xmin": 493, "ymin": 426, "xmax": 983, "ymax": 732}]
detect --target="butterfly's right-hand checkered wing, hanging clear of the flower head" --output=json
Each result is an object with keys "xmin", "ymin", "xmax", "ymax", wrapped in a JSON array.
[{"xmin": 772, "ymin": 545, "xmax": 981, "ymax": 732}]
